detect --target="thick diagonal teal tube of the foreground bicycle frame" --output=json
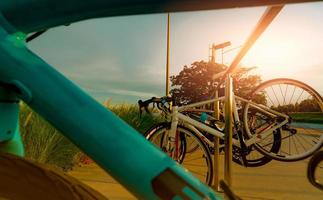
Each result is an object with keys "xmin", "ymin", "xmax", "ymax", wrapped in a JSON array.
[{"xmin": 0, "ymin": 29, "xmax": 219, "ymax": 199}]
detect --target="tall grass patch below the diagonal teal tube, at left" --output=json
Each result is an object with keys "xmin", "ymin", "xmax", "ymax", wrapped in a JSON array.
[{"xmin": 20, "ymin": 105, "xmax": 80, "ymax": 170}]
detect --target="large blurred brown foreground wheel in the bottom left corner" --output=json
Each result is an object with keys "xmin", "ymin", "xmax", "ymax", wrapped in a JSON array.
[{"xmin": 0, "ymin": 153, "xmax": 107, "ymax": 200}]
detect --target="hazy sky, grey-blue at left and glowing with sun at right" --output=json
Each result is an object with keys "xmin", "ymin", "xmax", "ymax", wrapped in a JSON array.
[{"xmin": 28, "ymin": 3, "xmax": 323, "ymax": 103}]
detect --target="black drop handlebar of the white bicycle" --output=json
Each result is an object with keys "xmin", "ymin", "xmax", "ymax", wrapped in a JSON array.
[{"xmin": 138, "ymin": 96, "xmax": 174, "ymax": 116}]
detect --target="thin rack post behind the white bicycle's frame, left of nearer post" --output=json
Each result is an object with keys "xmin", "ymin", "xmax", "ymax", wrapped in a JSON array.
[{"xmin": 213, "ymin": 90, "xmax": 220, "ymax": 191}]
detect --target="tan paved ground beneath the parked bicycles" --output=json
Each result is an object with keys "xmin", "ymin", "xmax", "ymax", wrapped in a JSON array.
[{"xmin": 71, "ymin": 156, "xmax": 323, "ymax": 200}]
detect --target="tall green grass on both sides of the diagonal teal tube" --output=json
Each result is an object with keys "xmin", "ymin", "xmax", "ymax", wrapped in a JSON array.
[{"xmin": 20, "ymin": 104, "xmax": 162, "ymax": 170}]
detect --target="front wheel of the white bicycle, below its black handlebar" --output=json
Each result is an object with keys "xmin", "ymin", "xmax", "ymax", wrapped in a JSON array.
[{"xmin": 145, "ymin": 123, "xmax": 213, "ymax": 185}]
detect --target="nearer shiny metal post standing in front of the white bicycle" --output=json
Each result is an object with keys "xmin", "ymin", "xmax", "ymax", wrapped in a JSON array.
[{"xmin": 224, "ymin": 74, "xmax": 233, "ymax": 190}]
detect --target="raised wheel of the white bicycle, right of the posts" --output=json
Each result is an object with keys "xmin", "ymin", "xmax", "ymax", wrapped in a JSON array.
[{"xmin": 243, "ymin": 78, "xmax": 323, "ymax": 161}]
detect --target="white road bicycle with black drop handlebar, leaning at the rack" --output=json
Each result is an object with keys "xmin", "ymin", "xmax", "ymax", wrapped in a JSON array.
[{"xmin": 139, "ymin": 79, "xmax": 323, "ymax": 185}]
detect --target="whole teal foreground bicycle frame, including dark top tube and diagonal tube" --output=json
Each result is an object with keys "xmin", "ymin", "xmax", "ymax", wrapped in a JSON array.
[{"xmin": 0, "ymin": 0, "xmax": 316, "ymax": 199}]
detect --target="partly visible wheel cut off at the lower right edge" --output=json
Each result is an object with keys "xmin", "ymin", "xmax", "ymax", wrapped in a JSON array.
[{"xmin": 307, "ymin": 151, "xmax": 323, "ymax": 190}]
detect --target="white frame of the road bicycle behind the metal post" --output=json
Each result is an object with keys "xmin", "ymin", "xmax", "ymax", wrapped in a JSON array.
[{"xmin": 170, "ymin": 96, "xmax": 289, "ymax": 150}]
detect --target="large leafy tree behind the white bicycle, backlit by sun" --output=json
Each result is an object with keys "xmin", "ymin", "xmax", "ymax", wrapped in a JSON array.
[{"xmin": 170, "ymin": 61, "xmax": 264, "ymax": 104}]
